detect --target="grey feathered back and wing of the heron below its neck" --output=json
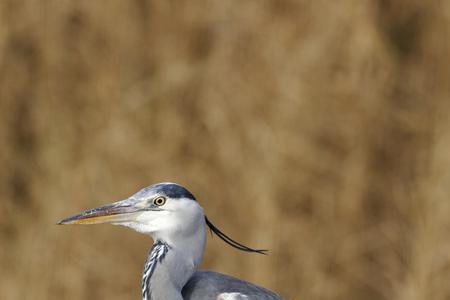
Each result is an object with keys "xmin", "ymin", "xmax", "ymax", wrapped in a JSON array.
[{"xmin": 182, "ymin": 271, "xmax": 283, "ymax": 300}]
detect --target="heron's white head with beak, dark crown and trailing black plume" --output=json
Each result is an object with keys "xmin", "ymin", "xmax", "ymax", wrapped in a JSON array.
[{"xmin": 58, "ymin": 183, "xmax": 266, "ymax": 254}]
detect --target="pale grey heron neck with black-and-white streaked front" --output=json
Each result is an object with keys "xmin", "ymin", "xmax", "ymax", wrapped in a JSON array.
[{"xmin": 142, "ymin": 226, "xmax": 206, "ymax": 300}]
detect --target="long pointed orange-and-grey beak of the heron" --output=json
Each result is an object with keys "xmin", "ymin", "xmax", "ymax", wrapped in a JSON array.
[{"xmin": 57, "ymin": 199, "xmax": 143, "ymax": 225}]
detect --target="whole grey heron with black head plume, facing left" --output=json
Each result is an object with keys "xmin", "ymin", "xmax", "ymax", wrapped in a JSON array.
[{"xmin": 58, "ymin": 183, "xmax": 282, "ymax": 300}]
